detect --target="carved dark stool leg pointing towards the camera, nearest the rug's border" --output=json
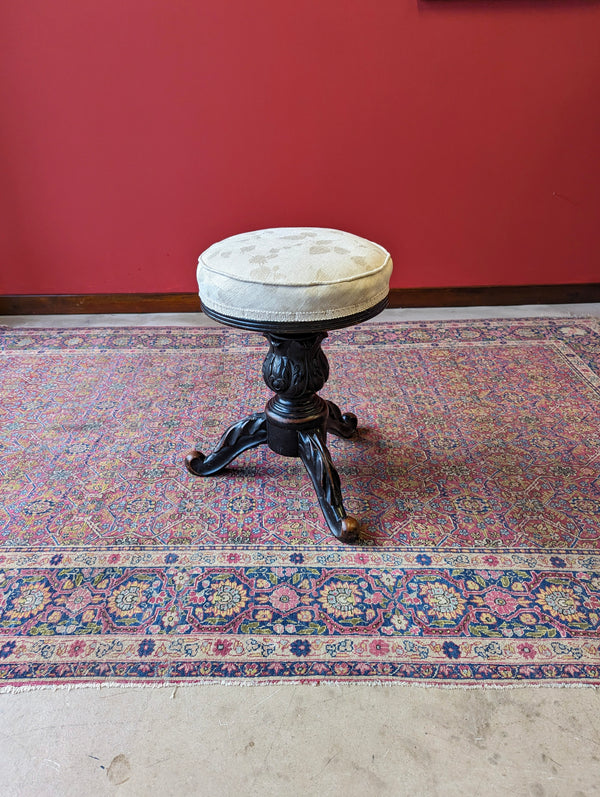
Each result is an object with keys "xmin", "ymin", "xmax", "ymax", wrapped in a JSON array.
[{"xmin": 298, "ymin": 430, "xmax": 359, "ymax": 543}]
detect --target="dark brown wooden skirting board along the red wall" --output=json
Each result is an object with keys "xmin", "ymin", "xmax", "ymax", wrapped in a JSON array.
[{"xmin": 0, "ymin": 283, "xmax": 600, "ymax": 315}]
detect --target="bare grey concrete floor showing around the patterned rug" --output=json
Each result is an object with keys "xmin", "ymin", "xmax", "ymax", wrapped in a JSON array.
[{"xmin": 0, "ymin": 304, "xmax": 600, "ymax": 797}]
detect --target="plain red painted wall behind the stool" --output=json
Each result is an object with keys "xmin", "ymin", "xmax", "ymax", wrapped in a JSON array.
[{"xmin": 0, "ymin": 0, "xmax": 600, "ymax": 294}]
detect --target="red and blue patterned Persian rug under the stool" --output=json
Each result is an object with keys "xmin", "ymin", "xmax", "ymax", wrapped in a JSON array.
[{"xmin": 0, "ymin": 319, "xmax": 600, "ymax": 688}]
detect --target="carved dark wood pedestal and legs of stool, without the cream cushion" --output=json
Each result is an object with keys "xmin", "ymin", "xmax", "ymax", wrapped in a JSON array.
[{"xmin": 186, "ymin": 297, "xmax": 388, "ymax": 543}]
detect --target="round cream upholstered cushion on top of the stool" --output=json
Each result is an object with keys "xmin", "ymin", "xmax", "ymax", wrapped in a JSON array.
[{"xmin": 198, "ymin": 227, "xmax": 392, "ymax": 322}]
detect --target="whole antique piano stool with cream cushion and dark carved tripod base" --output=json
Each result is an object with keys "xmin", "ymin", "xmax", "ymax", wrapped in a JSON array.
[{"xmin": 186, "ymin": 227, "xmax": 392, "ymax": 543}]
